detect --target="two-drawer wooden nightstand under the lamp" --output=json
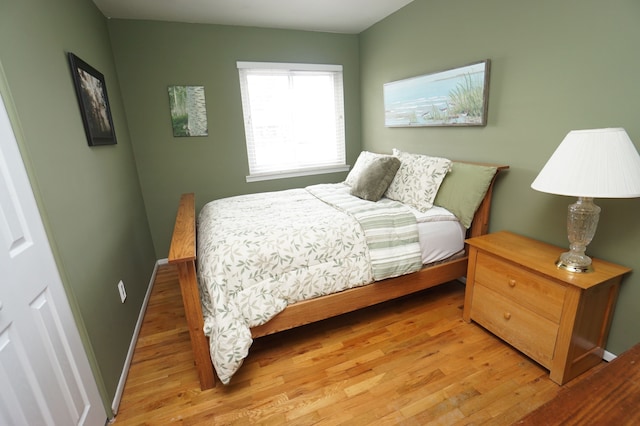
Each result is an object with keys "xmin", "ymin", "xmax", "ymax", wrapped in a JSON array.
[{"xmin": 463, "ymin": 231, "xmax": 631, "ymax": 385}]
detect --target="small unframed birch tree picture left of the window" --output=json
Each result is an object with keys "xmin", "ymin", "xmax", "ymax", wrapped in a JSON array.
[{"xmin": 169, "ymin": 86, "xmax": 209, "ymax": 136}]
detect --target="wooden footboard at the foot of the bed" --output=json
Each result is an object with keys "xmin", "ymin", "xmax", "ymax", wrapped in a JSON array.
[{"xmin": 169, "ymin": 193, "xmax": 215, "ymax": 390}]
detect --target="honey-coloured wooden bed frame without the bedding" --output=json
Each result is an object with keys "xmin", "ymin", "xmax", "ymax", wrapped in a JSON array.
[{"xmin": 168, "ymin": 163, "xmax": 509, "ymax": 390}]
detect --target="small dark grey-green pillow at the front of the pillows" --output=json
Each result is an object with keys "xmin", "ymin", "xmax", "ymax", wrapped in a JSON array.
[{"xmin": 351, "ymin": 156, "xmax": 400, "ymax": 201}]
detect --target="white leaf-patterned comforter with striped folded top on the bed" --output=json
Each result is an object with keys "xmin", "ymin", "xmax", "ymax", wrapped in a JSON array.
[{"xmin": 197, "ymin": 184, "xmax": 421, "ymax": 384}]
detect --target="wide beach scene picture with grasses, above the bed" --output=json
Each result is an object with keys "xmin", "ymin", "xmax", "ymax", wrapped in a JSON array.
[{"xmin": 383, "ymin": 59, "xmax": 490, "ymax": 127}]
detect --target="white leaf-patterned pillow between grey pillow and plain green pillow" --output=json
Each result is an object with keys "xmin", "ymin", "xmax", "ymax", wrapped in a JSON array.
[{"xmin": 385, "ymin": 148, "xmax": 451, "ymax": 212}]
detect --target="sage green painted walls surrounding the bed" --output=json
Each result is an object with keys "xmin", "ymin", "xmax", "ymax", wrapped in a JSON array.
[{"xmin": 0, "ymin": 0, "xmax": 640, "ymax": 414}]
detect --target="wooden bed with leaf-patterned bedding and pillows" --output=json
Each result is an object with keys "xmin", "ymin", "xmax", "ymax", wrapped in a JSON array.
[{"xmin": 168, "ymin": 150, "xmax": 508, "ymax": 390}]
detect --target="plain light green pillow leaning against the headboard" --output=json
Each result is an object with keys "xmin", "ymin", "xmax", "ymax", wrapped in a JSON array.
[{"xmin": 433, "ymin": 162, "xmax": 498, "ymax": 229}]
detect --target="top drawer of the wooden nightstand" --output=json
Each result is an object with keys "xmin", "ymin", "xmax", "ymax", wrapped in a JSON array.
[{"xmin": 475, "ymin": 253, "xmax": 566, "ymax": 324}]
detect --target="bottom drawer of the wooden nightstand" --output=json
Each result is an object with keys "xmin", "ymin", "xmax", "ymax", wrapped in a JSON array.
[{"xmin": 473, "ymin": 283, "xmax": 558, "ymax": 368}]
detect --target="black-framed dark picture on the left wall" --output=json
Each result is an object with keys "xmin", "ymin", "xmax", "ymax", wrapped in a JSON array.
[{"xmin": 67, "ymin": 52, "xmax": 116, "ymax": 146}]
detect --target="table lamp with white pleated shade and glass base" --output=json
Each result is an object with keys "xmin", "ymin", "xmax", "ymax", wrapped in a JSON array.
[{"xmin": 531, "ymin": 128, "xmax": 640, "ymax": 273}]
